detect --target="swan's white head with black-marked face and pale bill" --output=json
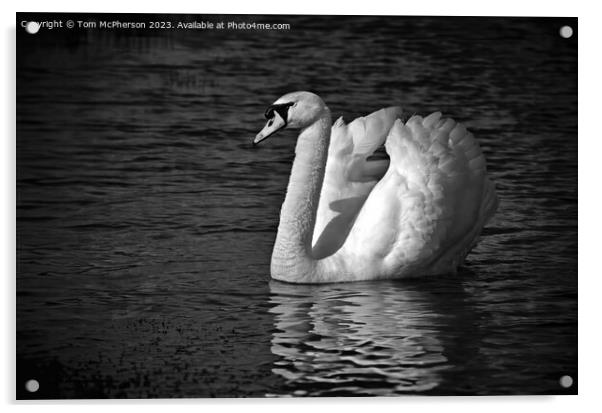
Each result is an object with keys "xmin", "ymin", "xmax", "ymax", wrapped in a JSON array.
[{"xmin": 253, "ymin": 92, "xmax": 327, "ymax": 145}]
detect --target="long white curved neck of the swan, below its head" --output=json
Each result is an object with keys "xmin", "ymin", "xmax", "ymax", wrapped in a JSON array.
[{"xmin": 271, "ymin": 108, "xmax": 331, "ymax": 282}]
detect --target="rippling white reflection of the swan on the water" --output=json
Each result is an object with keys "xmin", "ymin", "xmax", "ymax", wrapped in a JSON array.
[{"xmin": 270, "ymin": 281, "xmax": 464, "ymax": 396}]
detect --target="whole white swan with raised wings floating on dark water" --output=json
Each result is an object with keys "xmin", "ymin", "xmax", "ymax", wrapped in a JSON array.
[{"xmin": 253, "ymin": 91, "xmax": 498, "ymax": 283}]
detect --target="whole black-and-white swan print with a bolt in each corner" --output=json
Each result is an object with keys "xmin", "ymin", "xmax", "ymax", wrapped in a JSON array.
[{"xmin": 15, "ymin": 13, "xmax": 579, "ymax": 400}]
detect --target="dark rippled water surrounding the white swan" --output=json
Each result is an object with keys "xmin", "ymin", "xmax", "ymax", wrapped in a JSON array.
[{"xmin": 17, "ymin": 16, "xmax": 577, "ymax": 398}]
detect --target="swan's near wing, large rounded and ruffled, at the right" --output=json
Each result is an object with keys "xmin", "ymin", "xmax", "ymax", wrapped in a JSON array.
[{"xmin": 332, "ymin": 112, "xmax": 497, "ymax": 277}]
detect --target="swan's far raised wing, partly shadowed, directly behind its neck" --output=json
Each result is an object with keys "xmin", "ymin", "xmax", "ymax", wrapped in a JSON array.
[{"xmin": 312, "ymin": 107, "xmax": 402, "ymax": 258}]
